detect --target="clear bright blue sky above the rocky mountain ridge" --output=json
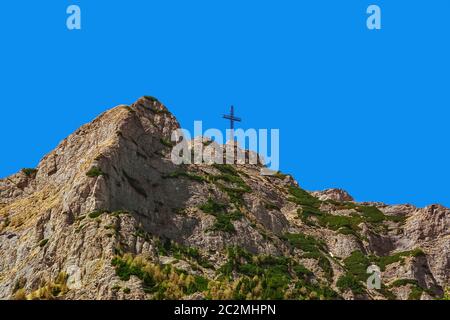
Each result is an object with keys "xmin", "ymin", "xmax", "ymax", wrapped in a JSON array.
[{"xmin": 0, "ymin": 0, "xmax": 450, "ymax": 206}]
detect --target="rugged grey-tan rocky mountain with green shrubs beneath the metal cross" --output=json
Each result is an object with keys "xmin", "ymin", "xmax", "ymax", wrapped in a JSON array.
[{"xmin": 0, "ymin": 97, "xmax": 450, "ymax": 299}]
